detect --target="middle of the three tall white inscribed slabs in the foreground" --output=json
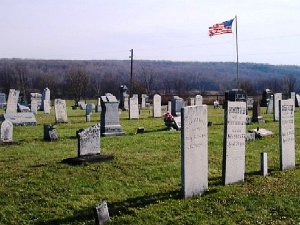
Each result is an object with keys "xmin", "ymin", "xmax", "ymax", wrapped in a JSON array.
[{"xmin": 222, "ymin": 101, "xmax": 247, "ymax": 185}]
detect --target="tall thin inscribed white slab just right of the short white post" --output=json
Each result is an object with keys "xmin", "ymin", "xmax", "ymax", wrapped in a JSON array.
[{"xmin": 279, "ymin": 99, "xmax": 296, "ymax": 170}]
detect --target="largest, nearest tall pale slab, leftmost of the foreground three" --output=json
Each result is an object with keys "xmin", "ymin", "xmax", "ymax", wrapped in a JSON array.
[{"xmin": 181, "ymin": 105, "xmax": 208, "ymax": 198}]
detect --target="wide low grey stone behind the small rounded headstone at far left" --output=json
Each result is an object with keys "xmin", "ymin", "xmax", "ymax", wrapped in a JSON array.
[{"xmin": 3, "ymin": 112, "xmax": 36, "ymax": 126}]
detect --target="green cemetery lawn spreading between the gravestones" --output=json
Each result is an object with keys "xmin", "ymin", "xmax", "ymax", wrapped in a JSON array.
[{"xmin": 0, "ymin": 101, "xmax": 300, "ymax": 225}]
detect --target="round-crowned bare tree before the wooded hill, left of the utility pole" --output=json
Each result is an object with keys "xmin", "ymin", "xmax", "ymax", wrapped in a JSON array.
[{"xmin": 65, "ymin": 68, "xmax": 90, "ymax": 105}]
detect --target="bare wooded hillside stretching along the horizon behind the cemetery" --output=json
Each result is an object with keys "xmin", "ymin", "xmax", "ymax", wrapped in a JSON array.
[{"xmin": 0, "ymin": 59, "xmax": 300, "ymax": 103}]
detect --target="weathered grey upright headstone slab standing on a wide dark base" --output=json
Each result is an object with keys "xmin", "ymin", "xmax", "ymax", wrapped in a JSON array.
[{"xmin": 77, "ymin": 124, "xmax": 100, "ymax": 157}]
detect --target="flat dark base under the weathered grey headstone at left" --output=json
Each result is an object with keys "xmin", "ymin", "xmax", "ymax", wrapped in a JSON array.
[{"xmin": 62, "ymin": 154, "xmax": 114, "ymax": 165}]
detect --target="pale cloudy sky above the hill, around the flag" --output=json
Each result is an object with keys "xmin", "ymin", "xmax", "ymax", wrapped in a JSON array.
[{"xmin": 0, "ymin": 0, "xmax": 300, "ymax": 65}]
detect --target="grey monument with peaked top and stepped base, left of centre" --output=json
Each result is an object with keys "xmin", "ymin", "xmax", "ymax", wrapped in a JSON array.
[{"xmin": 101, "ymin": 93, "xmax": 124, "ymax": 136}]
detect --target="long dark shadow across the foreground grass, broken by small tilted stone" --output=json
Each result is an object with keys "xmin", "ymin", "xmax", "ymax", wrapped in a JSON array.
[{"xmin": 34, "ymin": 191, "xmax": 181, "ymax": 225}]
